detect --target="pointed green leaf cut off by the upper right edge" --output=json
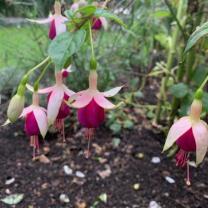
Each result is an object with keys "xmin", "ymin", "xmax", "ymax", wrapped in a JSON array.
[{"xmin": 184, "ymin": 22, "xmax": 208, "ymax": 53}]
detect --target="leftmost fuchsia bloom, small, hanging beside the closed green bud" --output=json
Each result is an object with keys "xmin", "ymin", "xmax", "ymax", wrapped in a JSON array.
[{"xmin": 20, "ymin": 93, "xmax": 48, "ymax": 158}]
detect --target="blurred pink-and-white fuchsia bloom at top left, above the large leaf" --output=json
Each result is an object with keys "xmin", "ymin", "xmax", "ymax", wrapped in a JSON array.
[{"xmin": 28, "ymin": 1, "xmax": 68, "ymax": 40}]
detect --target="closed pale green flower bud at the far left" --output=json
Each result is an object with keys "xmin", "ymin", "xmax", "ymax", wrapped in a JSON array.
[{"xmin": 7, "ymin": 94, "xmax": 25, "ymax": 122}]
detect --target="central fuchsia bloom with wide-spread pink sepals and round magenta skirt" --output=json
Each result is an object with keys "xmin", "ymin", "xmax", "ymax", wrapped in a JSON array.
[{"xmin": 68, "ymin": 71, "xmax": 122, "ymax": 157}]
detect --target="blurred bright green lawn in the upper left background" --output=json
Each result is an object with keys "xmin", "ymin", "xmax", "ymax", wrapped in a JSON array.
[{"xmin": 0, "ymin": 26, "xmax": 48, "ymax": 69}]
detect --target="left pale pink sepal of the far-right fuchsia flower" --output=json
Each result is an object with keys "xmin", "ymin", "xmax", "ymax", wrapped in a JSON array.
[{"xmin": 163, "ymin": 116, "xmax": 192, "ymax": 151}]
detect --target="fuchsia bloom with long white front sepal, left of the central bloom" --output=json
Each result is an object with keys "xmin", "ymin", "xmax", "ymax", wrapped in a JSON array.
[{"xmin": 27, "ymin": 68, "xmax": 74, "ymax": 141}]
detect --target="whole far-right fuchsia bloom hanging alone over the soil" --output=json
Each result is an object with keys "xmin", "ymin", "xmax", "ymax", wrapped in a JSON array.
[{"xmin": 163, "ymin": 100, "xmax": 208, "ymax": 185}]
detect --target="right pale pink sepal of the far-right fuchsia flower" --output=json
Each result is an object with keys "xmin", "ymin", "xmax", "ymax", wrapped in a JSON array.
[{"xmin": 193, "ymin": 121, "xmax": 208, "ymax": 165}]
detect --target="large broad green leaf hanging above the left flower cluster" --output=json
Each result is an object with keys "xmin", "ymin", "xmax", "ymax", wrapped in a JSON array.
[{"xmin": 48, "ymin": 30, "xmax": 86, "ymax": 71}]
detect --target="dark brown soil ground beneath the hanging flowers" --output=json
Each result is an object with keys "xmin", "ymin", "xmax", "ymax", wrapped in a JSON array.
[{"xmin": 0, "ymin": 110, "xmax": 208, "ymax": 208}]
